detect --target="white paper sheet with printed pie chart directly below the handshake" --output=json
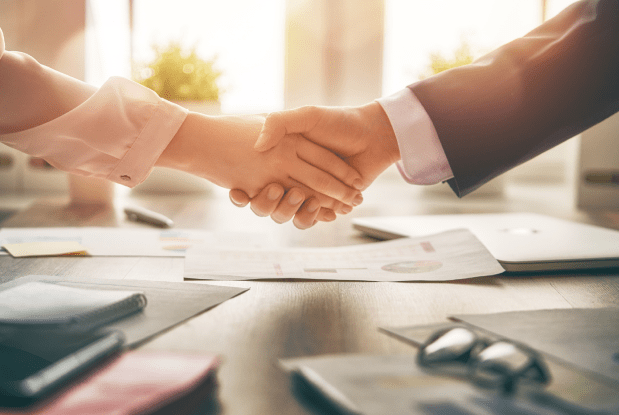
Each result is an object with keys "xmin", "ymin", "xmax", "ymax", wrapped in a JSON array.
[{"xmin": 185, "ymin": 229, "xmax": 503, "ymax": 281}]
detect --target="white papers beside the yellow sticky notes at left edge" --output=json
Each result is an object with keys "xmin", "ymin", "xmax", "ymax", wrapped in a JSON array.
[{"xmin": 0, "ymin": 227, "xmax": 215, "ymax": 257}]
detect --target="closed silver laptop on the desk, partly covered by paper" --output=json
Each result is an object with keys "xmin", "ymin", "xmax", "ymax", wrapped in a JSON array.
[{"xmin": 353, "ymin": 213, "xmax": 619, "ymax": 272}]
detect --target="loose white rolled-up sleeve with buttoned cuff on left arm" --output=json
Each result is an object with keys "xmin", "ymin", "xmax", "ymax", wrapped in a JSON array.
[{"xmin": 0, "ymin": 77, "xmax": 187, "ymax": 187}]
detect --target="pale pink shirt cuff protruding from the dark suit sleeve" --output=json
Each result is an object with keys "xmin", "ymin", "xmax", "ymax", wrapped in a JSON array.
[{"xmin": 377, "ymin": 88, "xmax": 453, "ymax": 185}]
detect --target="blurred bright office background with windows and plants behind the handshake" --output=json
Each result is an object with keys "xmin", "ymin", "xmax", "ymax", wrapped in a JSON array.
[{"xmin": 0, "ymin": 0, "xmax": 616, "ymax": 208}]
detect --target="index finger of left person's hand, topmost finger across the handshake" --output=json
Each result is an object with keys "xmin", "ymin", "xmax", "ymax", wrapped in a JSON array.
[{"xmin": 295, "ymin": 137, "xmax": 363, "ymax": 190}]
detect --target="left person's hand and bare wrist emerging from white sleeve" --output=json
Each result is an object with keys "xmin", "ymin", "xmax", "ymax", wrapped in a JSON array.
[{"xmin": 157, "ymin": 113, "xmax": 360, "ymax": 211}]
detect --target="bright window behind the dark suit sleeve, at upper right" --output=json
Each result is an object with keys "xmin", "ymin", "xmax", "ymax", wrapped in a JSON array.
[{"xmin": 383, "ymin": 0, "xmax": 574, "ymax": 95}]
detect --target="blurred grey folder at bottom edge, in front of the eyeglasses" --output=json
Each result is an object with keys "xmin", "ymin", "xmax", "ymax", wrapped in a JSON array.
[{"xmin": 280, "ymin": 354, "xmax": 565, "ymax": 415}]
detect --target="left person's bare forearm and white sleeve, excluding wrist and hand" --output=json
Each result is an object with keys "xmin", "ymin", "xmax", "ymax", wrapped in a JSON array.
[{"xmin": 0, "ymin": 25, "xmax": 187, "ymax": 187}]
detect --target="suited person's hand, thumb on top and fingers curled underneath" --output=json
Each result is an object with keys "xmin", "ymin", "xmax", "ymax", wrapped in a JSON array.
[{"xmin": 230, "ymin": 102, "xmax": 400, "ymax": 227}]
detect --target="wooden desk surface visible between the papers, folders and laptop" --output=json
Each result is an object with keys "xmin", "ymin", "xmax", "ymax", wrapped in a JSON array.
[{"xmin": 0, "ymin": 181, "xmax": 619, "ymax": 415}]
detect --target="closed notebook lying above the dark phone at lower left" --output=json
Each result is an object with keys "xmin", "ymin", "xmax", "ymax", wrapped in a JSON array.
[{"xmin": 0, "ymin": 282, "xmax": 146, "ymax": 331}]
